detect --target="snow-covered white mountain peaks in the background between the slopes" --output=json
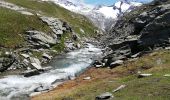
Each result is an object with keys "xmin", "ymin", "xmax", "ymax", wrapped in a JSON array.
[{"xmin": 43, "ymin": 0, "xmax": 142, "ymax": 30}]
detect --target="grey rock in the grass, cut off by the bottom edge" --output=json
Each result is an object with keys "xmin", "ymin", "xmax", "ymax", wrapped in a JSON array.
[{"xmin": 95, "ymin": 92, "xmax": 114, "ymax": 100}]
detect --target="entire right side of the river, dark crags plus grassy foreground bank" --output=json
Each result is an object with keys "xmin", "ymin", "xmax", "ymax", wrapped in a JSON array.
[{"xmin": 33, "ymin": 0, "xmax": 170, "ymax": 100}]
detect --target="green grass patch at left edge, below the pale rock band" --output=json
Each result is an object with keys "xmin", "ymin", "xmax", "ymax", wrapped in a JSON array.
[{"xmin": 0, "ymin": 8, "xmax": 51, "ymax": 48}]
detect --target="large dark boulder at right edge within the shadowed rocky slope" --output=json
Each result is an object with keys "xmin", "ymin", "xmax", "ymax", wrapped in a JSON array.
[{"xmin": 139, "ymin": 11, "xmax": 170, "ymax": 46}]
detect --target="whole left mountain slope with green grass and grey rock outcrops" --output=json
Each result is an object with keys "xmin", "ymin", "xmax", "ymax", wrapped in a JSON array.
[{"xmin": 0, "ymin": 0, "xmax": 98, "ymax": 72}]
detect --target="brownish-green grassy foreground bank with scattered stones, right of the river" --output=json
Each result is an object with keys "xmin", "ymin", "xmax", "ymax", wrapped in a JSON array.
[{"xmin": 32, "ymin": 50, "xmax": 170, "ymax": 100}]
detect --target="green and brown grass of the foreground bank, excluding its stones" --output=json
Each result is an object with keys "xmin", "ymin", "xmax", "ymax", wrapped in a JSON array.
[{"xmin": 43, "ymin": 51, "xmax": 170, "ymax": 100}]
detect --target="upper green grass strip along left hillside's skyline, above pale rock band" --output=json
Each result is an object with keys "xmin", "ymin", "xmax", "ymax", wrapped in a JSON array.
[{"xmin": 6, "ymin": 0, "xmax": 97, "ymax": 37}]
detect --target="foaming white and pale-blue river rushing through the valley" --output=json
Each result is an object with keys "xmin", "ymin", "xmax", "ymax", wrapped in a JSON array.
[{"xmin": 0, "ymin": 44, "xmax": 102, "ymax": 100}]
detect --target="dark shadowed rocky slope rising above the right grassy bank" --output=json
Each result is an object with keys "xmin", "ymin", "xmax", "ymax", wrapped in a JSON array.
[{"xmin": 97, "ymin": 0, "xmax": 170, "ymax": 68}]
